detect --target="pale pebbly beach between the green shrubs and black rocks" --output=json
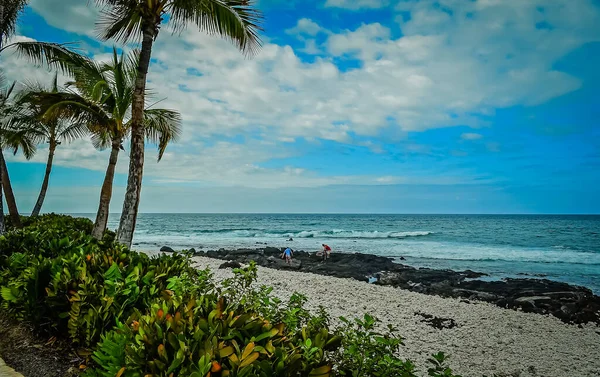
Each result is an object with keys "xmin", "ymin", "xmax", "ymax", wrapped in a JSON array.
[{"xmin": 194, "ymin": 257, "xmax": 600, "ymax": 377}]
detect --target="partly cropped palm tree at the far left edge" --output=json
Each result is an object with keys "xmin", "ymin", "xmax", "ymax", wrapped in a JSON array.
[{"xmin": 0, "ymin": 74, "xmax": 35, "ymax": 234}]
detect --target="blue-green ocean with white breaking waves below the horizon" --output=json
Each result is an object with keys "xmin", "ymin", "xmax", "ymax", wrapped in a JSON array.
[{"xmin": 88, "ymin": 214, "xmax": 600, "ymax": 294}]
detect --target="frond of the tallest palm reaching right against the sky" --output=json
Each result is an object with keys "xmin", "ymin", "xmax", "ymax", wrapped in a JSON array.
[{"xmin": 167, "ymin": 0, "xmax": 263, "ymax": 56}]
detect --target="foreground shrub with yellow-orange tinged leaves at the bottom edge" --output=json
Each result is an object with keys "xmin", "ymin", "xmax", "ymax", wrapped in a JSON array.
[{"xmin": 88, "ymin": 266, "xmax": 341, "ymax": 377}]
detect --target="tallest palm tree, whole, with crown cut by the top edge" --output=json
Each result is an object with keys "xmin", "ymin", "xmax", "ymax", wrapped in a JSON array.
[{"xmin": 96, "ymin": 0, "xmax": 262, "ymax": 246}]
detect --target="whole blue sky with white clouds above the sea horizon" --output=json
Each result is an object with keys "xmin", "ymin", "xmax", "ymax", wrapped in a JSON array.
[{"xmin": 0, "ymin": 0, "xmax": 600, "ymax": 214}]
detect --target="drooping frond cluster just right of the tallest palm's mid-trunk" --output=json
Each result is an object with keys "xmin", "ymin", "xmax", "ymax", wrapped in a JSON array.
[{"xmin": 144, "ymin": 109, "xmax": 181, "ymax": 161}]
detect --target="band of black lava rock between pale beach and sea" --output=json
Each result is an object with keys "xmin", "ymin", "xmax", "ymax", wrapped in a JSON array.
[{"xmin": 161, "ymin": 247, "xmax": 600, "ymax": 324}]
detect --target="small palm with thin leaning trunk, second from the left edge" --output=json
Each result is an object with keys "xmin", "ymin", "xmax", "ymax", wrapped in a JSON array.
[{"xmin": 15, "ymin": 75, "xmax": 89, "ymax": 216}]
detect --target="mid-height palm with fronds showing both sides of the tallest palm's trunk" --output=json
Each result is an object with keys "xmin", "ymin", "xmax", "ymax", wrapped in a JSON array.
[{"xmin": 24, "ymin": 46, "xmax": 181, "ymax": 239}]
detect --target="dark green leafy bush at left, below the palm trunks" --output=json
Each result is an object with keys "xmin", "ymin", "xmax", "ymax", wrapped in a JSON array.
[{"xmin": 0, "ymin": 216, "xmax": 198, "ymax": 347}]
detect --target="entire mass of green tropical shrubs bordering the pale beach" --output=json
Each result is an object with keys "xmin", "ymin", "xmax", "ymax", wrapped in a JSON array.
[{"xmin": 0, "ymin": 215, "xmax": 462, "ymax": 377}]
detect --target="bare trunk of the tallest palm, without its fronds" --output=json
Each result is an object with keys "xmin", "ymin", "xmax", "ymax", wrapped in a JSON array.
[{"xmin": 117, "ymin": 25, "xmax": 156, "ymax": 247}]
